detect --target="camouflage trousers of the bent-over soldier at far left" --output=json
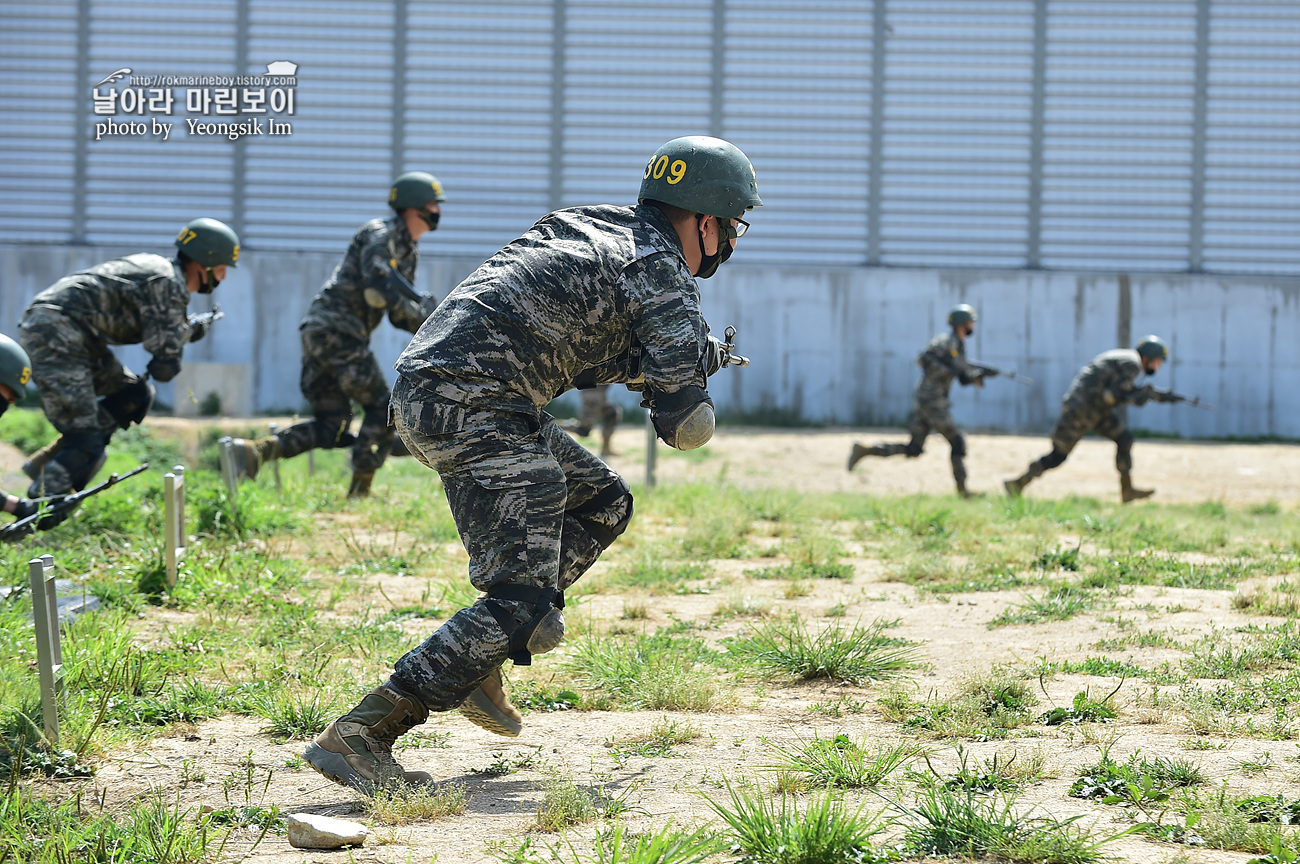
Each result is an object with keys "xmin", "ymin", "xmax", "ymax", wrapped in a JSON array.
[{"xmin": 18, "ymin": 307, "xmax": 139, "ymax": 435}]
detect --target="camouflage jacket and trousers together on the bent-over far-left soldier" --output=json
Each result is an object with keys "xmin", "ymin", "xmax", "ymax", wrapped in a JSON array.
[{"xmin": 18, "ymin": 252, "xmax": 190, "ymax": 433}]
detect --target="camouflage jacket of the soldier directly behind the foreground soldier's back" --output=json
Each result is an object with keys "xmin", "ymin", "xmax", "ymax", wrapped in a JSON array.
[{"xmin": 299, "ymin": 213, "xmax": 424, "ymax": 342}]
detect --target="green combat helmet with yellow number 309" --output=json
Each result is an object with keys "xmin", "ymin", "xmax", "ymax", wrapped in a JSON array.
[{"xmin": 637, "ymin": 135, "xmax": 763, "ymax": 220}]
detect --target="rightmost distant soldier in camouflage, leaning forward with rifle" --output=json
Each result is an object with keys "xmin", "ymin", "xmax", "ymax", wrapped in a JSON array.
[{"xmin": 1004, "ymin": 337, "xmax": 1173, "ymax": 503}]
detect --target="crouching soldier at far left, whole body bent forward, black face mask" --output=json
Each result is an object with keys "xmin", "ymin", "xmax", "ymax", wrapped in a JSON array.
[{"xmin": 18, "ymin": 218, "xmax": 239, "ymax": 506}]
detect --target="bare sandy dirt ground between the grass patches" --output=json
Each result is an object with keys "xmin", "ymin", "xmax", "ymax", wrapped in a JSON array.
[{"xmin": 10, "ymin": 418, "xmax": 1300, "ymax": 864}]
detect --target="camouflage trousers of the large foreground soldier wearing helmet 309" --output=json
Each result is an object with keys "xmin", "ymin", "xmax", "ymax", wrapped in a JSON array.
[{"xmin": 393, "ymin": 379, "xmax": 632, "ymax": 711}]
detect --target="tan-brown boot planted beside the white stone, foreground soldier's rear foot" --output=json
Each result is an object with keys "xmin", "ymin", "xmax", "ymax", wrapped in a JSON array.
[{"xmin": 303, "ymin": 685, "xmax": 433, "ymax": 794}]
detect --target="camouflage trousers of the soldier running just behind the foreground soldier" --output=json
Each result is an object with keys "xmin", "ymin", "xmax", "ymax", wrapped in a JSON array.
[{"xmin": 276, "ymin": 330, "xmax": 393, "ymax": 474}]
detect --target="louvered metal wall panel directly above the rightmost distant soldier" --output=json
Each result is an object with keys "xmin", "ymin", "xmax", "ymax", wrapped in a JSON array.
[{"xmin": 1043, "ymin": 0, "xmax": 1196, "ymax": 270}]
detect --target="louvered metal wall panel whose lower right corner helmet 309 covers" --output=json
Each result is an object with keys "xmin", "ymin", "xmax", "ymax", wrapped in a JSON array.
[{"xmin": 558, "ymin": 0, "xmax": 714, "ymax": 207}]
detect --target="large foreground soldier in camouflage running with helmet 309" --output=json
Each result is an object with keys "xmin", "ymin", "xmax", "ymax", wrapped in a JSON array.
[{"xmin": 304, "ymin": 136, "xmax": 762, "ymax": 787}]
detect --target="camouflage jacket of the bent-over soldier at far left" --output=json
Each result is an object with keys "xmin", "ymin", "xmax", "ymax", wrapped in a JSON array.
[{"xmin": 29, "ymin": 252, "xmax": 190, "ymax": 361}]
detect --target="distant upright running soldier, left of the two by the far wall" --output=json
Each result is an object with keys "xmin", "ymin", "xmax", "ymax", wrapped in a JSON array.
[{"xmin": 849, "ymin": 303, "xmax": 997, "ymax": 498}]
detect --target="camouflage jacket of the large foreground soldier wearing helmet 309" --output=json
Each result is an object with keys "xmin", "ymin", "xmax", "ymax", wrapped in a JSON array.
[{"xmin": 397, "ymin": 205, "xmax": 707, "ymax": 414}]
